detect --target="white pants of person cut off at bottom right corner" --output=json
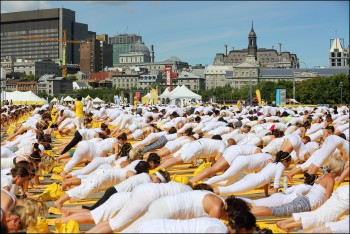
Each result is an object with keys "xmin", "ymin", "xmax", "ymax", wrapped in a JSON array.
[{"xmin": 293, "ymin": 185, "xmax": 349, "ymax": 228}]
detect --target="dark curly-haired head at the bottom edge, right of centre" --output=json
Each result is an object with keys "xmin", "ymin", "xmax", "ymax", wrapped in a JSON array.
[{"xmin": 227, "ymin": 211, "xmax": 257, "ymax": 234}]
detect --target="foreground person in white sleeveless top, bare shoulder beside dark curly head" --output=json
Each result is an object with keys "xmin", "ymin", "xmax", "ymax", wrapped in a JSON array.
[{"xmin": 122, "ymin": 184, "xmax": 227, "ymax": 233}]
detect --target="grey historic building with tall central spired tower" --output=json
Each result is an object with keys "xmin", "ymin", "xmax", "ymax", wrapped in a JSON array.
[{"xmin": 213, "ymin": 24, "xmax": 299, "ymax": 68}]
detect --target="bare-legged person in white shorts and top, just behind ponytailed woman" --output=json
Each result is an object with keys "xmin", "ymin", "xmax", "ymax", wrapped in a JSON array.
[{"xmin": 189, "ymin": 144, "xmax": 261, "ymax": 184}]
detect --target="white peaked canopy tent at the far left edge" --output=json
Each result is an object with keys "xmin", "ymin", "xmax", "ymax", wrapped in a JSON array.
[{"xmin": 5, "ymin": 90, "xmax": 46, "ymax": 105}]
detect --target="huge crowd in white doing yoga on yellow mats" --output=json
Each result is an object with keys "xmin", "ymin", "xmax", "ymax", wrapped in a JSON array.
[{"xmin": 1, "ymin": 95, "xmax": 349, "ymax": 233}]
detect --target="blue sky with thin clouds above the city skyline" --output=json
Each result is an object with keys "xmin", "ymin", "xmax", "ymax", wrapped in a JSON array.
[{"xmin": 1, "ymin": 1, "xmax": 349, "ymax": 68}]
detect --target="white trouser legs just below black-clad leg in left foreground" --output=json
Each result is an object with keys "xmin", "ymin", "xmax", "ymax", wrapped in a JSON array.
[{"xmin": 91, "ymin": 192, "xmax": 131, "ymax": 224}]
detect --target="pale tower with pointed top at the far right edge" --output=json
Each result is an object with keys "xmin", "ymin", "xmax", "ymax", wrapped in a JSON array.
[{"xmin": 329, "ymin": 38, "xmax": 350, "ymax": 67}]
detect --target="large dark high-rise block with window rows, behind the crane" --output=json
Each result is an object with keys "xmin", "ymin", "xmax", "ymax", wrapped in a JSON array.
[{"xmin": 1, "ymin": 8, "xmax": 88, "ymax": 64}]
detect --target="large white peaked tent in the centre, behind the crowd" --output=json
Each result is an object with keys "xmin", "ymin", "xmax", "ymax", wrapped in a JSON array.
[{"xmin": 167, "ymin": 85, "xmax": 202, "ymax": 106}]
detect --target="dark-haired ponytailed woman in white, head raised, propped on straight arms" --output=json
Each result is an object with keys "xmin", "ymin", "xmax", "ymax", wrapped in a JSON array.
[{"xmin": 214, "ymin": 151, "xmax": 291, "ymax": 196}]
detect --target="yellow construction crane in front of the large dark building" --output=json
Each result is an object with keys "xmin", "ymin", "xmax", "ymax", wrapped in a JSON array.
[{"xmin": 2, "ymin": 29, "xmax": 87, "ymax": 77}]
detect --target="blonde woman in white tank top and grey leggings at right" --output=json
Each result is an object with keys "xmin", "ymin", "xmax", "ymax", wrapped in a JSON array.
[{"xmin": 252, "ymin": 157, "xmax": 344, "ymax": 217}]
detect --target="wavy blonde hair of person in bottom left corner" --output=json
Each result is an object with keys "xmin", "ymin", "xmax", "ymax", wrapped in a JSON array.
[{"xmin": 11, "ymin": 198, "xmax": 46, "ymax": 229}]
